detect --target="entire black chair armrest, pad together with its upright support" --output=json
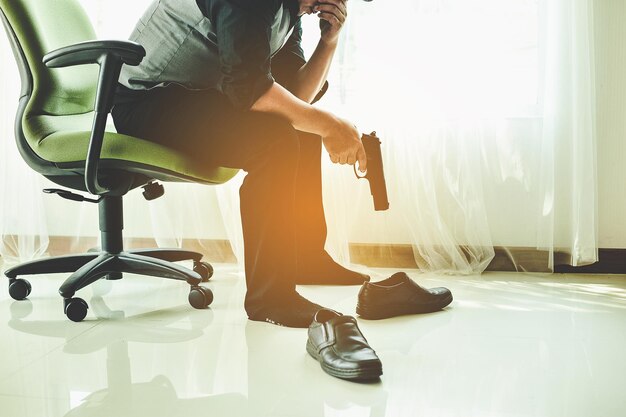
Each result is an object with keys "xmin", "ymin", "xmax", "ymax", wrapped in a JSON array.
[{"xmin": 43, "ymin": 41, "xmax": 146, "ymax": 195}]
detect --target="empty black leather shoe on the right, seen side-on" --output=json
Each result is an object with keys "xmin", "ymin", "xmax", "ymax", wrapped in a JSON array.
[{"xmin": 356, "ymin": 272, "xmax": 452, "ymax": 320}]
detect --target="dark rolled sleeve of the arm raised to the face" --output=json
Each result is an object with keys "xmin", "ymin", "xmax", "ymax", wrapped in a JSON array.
[{"xmin": 272, "ymin": 19, "xmax": 328, "ymax": 103}]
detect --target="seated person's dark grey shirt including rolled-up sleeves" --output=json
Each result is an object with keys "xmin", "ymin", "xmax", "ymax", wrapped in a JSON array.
[{"xmin": 117, "ymin": 0, "xmax": 306, "ymax": 109}]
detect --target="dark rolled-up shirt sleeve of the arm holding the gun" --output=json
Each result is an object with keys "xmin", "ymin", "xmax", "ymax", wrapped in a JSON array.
[{"xmin": 197, "ymin": 0, "xmax": 280, "ymax": 110}]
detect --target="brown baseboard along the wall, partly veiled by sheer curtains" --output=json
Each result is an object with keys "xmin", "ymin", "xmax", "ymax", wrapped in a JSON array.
[{"xmin": 6, "ymin": 236, "xmax": 626, "ymax": 274}]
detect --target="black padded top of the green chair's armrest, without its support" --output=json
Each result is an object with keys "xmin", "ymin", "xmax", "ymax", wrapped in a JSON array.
[{"xmin": 43, "ymin": 41, "xmax": 146, "ymax": 68}]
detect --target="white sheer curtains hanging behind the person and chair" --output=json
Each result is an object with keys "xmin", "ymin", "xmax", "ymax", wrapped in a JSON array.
[{"xmin": 0, "ymin": 0, "xmax": 597, "ymax": 273}]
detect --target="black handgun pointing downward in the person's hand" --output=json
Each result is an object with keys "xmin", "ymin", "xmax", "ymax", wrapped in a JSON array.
[{"xmin": 354, "ymin": 132, "xmax": 389, "ymax": 211}]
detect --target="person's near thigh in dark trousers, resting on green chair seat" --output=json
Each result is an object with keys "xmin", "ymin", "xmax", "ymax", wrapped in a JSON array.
[{"xmin": 113, "ymin": 86, "xmax": 296, "ymax": 170}]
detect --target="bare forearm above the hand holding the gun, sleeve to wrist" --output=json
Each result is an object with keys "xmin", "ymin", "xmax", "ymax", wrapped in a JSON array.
[{"xmin": 250, "ymin": 83, "xmax": 333, "ymax": 136}]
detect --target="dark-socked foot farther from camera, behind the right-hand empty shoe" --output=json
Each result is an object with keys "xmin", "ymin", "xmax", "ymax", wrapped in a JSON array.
[{"xmin": 296, "ymin": 252, "xmax": 370, "ymax": 285}]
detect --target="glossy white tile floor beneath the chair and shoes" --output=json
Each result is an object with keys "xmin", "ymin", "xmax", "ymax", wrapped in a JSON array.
[{"xmin": 0, "ymin": 265, "xmax": 626, "ymax": 417}]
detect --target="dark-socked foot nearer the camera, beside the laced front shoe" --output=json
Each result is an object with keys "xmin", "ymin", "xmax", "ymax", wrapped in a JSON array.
[{"xmin": 248, "ymin": 291, "xmax": 323, "ymax": 329}]
